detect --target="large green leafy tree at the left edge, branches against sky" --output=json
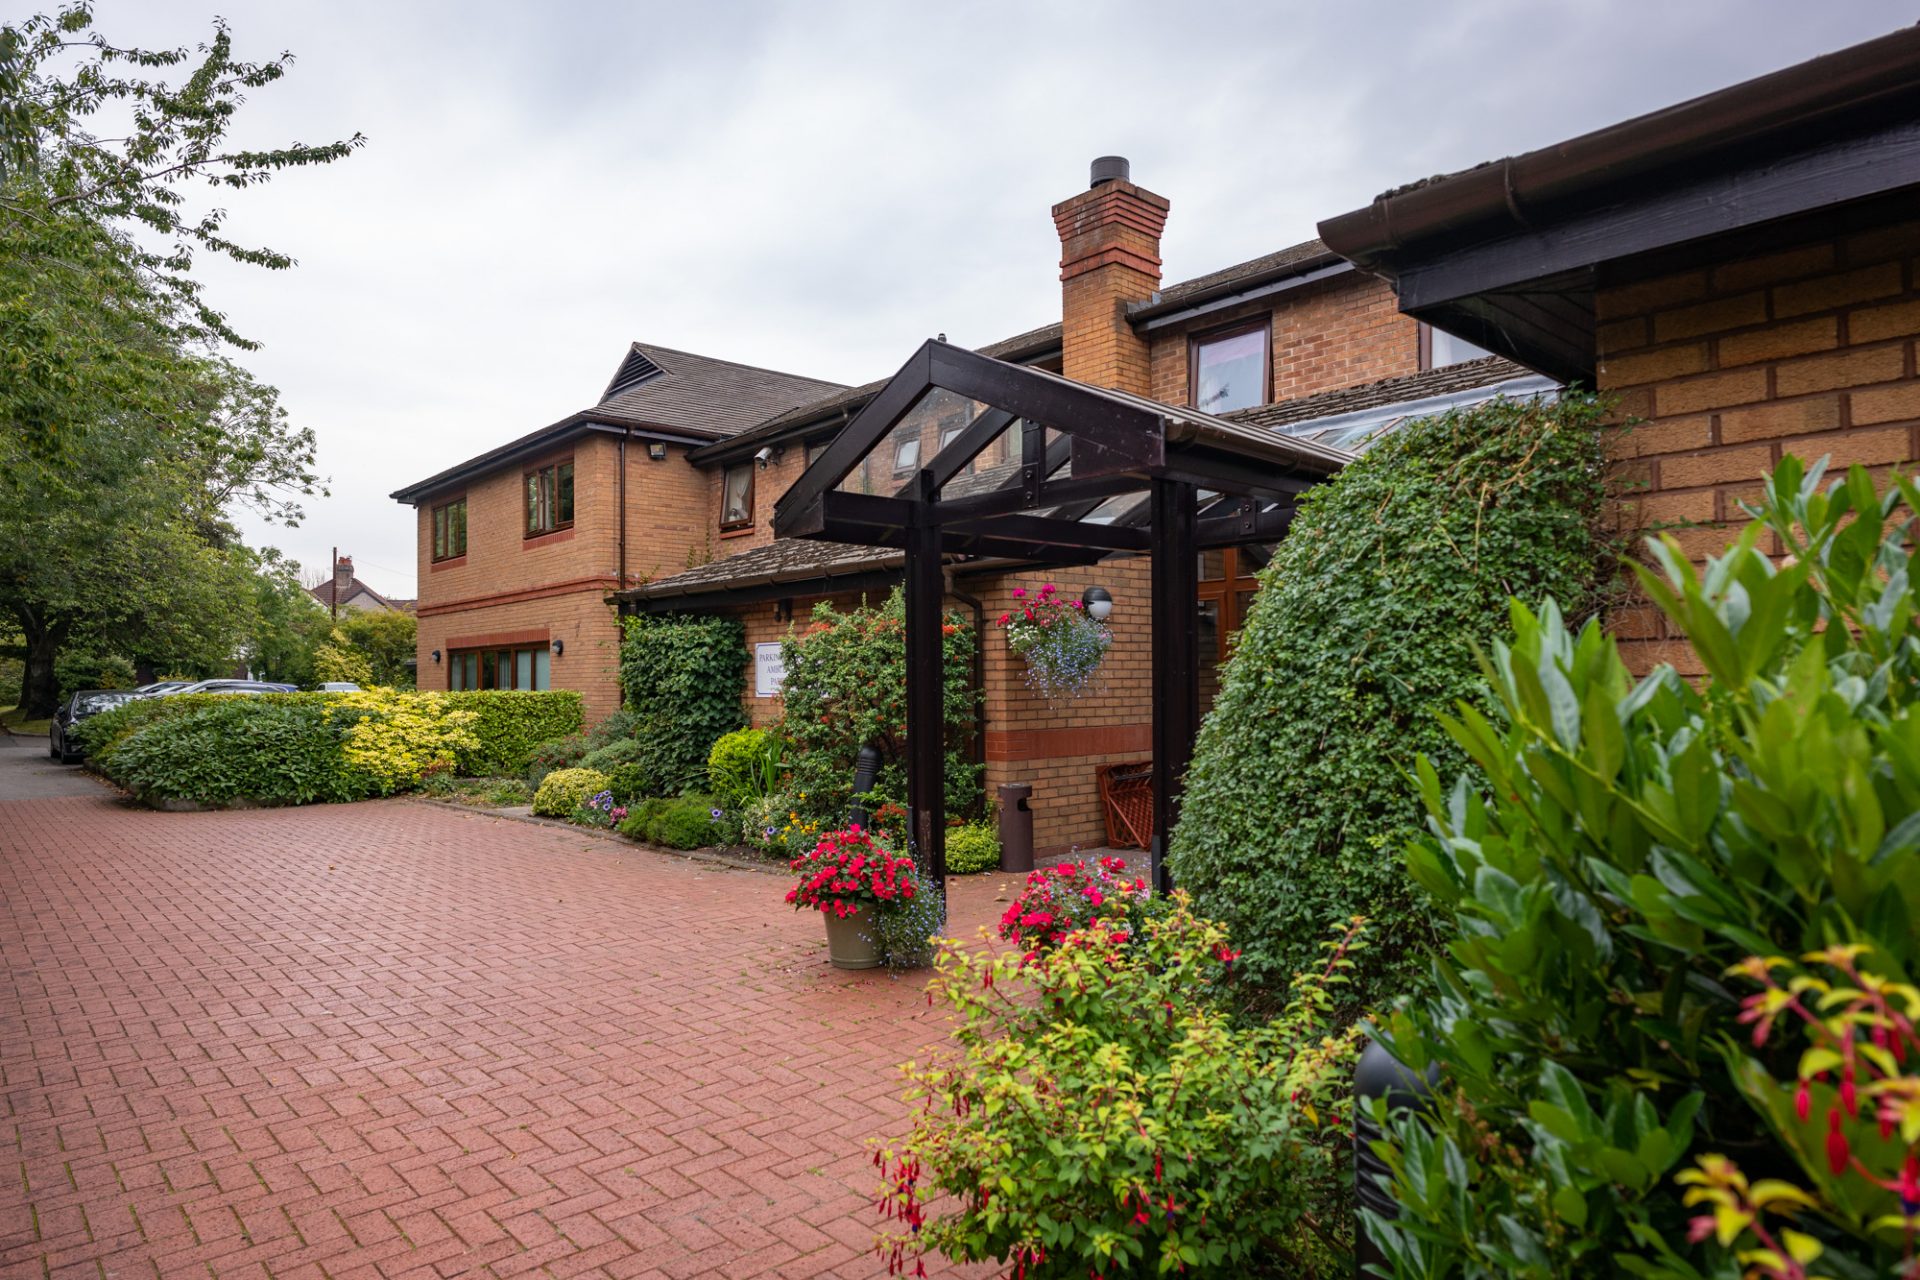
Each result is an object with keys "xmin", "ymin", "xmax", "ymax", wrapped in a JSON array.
[{"xmin": 0, "ymin": 4, "xmax": 359, "ymax": 716}]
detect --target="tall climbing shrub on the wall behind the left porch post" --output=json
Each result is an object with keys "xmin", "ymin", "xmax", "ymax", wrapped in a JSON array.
[{"xmin": 781, "ymin": 591, "xmax": 981, "ymax": 827}]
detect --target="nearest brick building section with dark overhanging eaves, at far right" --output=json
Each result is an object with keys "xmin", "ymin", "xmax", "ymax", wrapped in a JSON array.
[{"xmin": 1321, "ymin": 29, "xmax": 1920, "ymax": 674}]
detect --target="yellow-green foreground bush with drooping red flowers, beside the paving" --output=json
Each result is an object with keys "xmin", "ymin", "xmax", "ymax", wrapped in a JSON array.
[{"xmin": 879, "ymin": 894, "xmax": 1359, "ymax": 1280}]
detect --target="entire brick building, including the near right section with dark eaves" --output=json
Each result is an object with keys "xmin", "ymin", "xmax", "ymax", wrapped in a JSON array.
[{"xmin": 396, "ymin": 22, "xmax": 1920, "ymax": 848}]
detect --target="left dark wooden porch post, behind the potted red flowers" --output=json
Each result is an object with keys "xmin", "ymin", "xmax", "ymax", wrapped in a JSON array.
[{"xmin": 906, "ymin": 470, "xmax": 947, "ymax": 919}]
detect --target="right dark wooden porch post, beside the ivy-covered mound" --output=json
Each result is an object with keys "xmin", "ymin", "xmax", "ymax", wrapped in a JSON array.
[{"xmin": 1148, "ymin": 480, "xmax": 1200, "ymax": 892}]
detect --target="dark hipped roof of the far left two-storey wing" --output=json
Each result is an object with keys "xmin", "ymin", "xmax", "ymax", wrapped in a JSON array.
[{"xmin": 392, "ymin": 342, "xmax": 843, "ymax": 503}]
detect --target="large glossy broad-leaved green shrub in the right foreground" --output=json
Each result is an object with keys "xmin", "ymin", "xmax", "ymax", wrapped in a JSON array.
[{"xmin": 1375, "ymin": 457, "xmax": 1920, "ymax": 1280}]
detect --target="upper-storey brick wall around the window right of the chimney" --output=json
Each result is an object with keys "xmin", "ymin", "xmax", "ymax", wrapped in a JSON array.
[{"xmin": 1152, "ymin": 271, "xmax": 1421, "ymax": 405}]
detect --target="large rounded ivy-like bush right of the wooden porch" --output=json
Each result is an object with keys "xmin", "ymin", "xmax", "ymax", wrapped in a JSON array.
[{"xmin": 1169, "ymin": 393, "xmax": 1611, "ymax": 1002}]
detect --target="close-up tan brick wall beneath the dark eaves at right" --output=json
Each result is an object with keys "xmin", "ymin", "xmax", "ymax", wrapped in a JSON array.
[{"xmin": 1596, "ymin": 214, "xmax": 1920, "ymax": 674}]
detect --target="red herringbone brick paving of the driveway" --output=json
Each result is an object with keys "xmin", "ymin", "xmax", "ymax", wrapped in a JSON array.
[{"xmin": 0, "ymin": 796, "xmax": 1021, "ymax": 1280}]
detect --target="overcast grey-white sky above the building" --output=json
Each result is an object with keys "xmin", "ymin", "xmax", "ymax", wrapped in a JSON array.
[{"xmin": 82, "ymin": 0, "xmax": 1916, "ymax": 595}]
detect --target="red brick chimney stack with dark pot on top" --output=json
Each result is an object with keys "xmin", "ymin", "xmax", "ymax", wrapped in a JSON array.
[{"xmin": 1054, "ymin": 155, "xmax": 1167, "ymax": 395}]
